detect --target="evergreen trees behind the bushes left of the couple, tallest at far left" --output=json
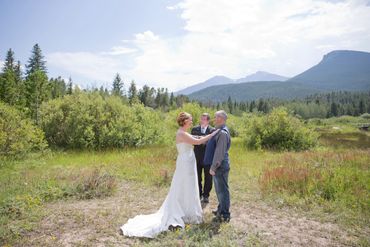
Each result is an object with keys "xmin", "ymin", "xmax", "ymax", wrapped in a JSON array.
[{"xmin": 0, "ymin": 44, "xmax": 189, "ymax": 124}]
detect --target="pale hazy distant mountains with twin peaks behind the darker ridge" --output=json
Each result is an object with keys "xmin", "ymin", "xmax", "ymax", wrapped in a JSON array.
[{"xmin": 176, "ymin": 71, "xmax": 289, "ymax": 95}]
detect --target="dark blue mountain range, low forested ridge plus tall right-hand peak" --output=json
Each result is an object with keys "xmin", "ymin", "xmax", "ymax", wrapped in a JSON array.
[{"xmin": 189, "ymin": 50, "xmax": 370, "ymax": 101}]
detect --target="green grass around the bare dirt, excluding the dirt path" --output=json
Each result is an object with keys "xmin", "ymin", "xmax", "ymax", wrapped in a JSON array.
[{"xmin": 0, "ymin": 127, "xmax": 370, "ymax": 246}]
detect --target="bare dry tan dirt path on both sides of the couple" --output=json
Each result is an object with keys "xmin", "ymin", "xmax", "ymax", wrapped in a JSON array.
[{"xmin": 19, "ymin": 182, "xmax": 351, "ymax": 247}]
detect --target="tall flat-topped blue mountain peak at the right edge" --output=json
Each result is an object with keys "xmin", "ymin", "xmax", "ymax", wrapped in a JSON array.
[{"xmin": 289, "ymin": 50, "xmax": 370, "ymax": 91}]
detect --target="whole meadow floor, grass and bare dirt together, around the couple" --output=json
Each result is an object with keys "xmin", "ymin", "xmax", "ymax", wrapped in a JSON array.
[{"xmin": 0, "ymin": 122, "xmax": 370, "ymax": 246}]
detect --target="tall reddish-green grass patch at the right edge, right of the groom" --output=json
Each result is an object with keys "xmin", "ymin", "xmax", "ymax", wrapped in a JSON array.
[{"xmin": 259, "ymin": 149, "xmax": 370, "ymax": 226}]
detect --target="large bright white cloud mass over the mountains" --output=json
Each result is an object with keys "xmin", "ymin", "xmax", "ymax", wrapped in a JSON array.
[{"xmin": 48, "ymin": 0, "xmax": 370, "ymax": 90}]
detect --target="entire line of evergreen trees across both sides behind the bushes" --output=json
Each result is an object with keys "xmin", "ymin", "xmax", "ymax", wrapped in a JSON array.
[{"xmin": 0, "ymin": 44, "xmax": 370, "ymax": 124}]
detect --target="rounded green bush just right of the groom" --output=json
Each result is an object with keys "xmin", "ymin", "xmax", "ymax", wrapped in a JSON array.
[{"xmin": 244, "ymin": 108, "xmax": 318, "ymax": 151}]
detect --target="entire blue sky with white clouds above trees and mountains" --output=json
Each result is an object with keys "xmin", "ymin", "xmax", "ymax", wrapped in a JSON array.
[{"xmin": 0, "ymin": 0, "xmax": 370, "ymax": 91}]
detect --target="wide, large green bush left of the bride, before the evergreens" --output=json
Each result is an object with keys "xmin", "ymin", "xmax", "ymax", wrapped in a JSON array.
[{"xmin": 41, "ymin": 92, "xmax": 163, "ymax": 149}]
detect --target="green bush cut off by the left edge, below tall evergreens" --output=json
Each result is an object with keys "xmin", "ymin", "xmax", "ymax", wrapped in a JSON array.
[{"xmin": 0, "ymin": 102, "xmax": 47, "ymax": 157}]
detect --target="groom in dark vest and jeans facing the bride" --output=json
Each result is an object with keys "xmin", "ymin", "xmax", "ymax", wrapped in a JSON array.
[{"xmin": 204, "ymin": 110, "xmax": 231, "ymax": 222}]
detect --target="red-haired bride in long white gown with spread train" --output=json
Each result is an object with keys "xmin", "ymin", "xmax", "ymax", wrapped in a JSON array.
[{"xmin": 121, "ymin": 112, "xmax": 218, "ymax": 238}]
